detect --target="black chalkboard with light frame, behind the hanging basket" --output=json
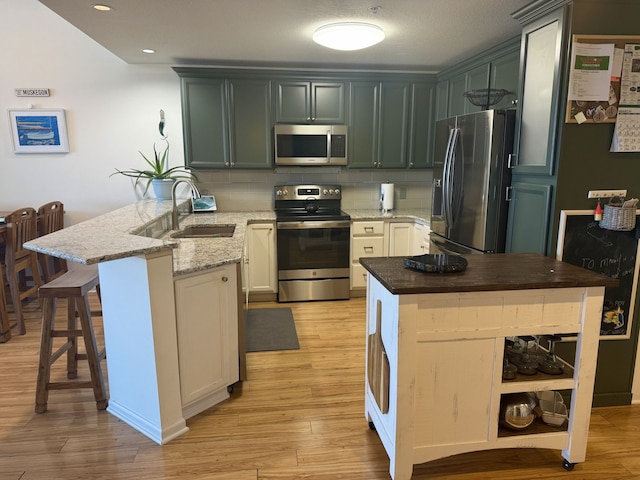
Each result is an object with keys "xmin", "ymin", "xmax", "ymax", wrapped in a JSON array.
[{"xmin": 556, "ymin": 210, "xmax": 640, "ymax": 339}]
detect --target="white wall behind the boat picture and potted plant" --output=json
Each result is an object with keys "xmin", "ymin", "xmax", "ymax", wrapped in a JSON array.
[{"xmin": 0, "ymin": 0, "xmax": 183, "ymax": 224}]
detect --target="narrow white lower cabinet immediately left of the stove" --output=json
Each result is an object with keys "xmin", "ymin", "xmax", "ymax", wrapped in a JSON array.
[{"xmin": 243, "ymin": 222, "xmax": 278, "ymax": 293}]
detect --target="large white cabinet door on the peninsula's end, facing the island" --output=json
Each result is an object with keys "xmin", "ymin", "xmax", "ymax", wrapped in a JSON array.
[{"xmin": 174, "ymin": 264, "xmax": 239, "ymax": 418}]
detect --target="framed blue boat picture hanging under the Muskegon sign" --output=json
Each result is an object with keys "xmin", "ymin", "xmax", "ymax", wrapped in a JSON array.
[{"xmin": 9, "ymin": 109, "xmax": 69, "ymax": 153}]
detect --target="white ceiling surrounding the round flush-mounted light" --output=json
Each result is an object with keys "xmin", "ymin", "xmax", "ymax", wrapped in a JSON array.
[{"xmin": 40, "ymin": 0, "xmax": 531, "ymax": 72}]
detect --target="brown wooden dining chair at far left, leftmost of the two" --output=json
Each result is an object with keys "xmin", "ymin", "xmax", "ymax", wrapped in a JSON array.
[{"xmin": 4, "ymin": 207, "xmax": 42, "ymax": 335}]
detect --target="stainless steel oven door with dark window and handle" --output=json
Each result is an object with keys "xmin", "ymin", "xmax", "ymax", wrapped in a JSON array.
[{"xmin": 277, "ymin": 220, "xmax": 350, "ymax": 280}]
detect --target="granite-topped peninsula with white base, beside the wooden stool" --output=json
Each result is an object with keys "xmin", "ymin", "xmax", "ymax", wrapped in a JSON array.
[{"xmin": 25, "ymin": 200, "xmax": 275, "ymax": 444}]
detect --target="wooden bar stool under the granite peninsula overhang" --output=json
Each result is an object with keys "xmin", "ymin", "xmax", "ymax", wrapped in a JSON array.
[{"xmin": 35, "ymin": 265, "xmax": 108, "ymax": 413}]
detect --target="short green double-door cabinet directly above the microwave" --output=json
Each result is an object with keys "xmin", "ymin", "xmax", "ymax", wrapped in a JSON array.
[{"xmin": 275, "ymin": 80, "xmax": 346, "ymax": 125}]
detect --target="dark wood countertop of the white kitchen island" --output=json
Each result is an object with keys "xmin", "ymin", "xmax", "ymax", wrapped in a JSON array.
[{"xmin": 360, "ymin": 253, "xmax": 618, "ymax": 294}]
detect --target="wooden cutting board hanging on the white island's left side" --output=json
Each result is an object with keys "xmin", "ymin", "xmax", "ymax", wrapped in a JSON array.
[{"xmin": 367, "ymin": 300, "xmax": 389, "ymax": 413}]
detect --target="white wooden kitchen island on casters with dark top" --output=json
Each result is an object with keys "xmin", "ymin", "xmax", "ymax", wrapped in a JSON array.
[{"xmin": 360, "ymin": 254, "xmax": 617, "ymax": 480}]
